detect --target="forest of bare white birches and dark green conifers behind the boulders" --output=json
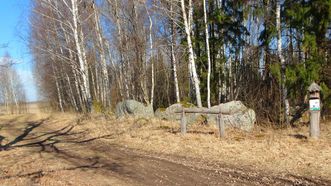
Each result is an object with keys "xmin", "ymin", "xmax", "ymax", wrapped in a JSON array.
[{"xmin": 29, "ymin": 0, "xmax": 331, "ymax": 124}]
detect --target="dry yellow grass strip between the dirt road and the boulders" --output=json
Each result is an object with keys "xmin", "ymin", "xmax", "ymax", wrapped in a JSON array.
[{"xmin": 78, "ymin": 115, "xmax": 331, "ymax": 179}]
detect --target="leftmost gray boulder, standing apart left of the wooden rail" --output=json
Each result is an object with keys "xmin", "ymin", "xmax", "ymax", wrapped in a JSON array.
[{"xmin": 115, "ymin": 100, "xmax": 154, "ymax": 118}]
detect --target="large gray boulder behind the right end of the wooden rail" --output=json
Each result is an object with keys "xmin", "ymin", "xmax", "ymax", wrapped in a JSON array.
[{"xmin": 207, "ymin": 101, "xmax": 256, "ymax": 131}]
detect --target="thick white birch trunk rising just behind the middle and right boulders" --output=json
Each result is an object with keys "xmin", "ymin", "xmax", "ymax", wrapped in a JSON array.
[{"xmin": 181, "ymin": 0, "xmax": 202, "ymax": 107}]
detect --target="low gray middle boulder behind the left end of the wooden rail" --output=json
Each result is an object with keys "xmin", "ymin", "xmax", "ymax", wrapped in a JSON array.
[{"xmin": 155, "ymin": 103, "xmax": 205, "ymax": 124}]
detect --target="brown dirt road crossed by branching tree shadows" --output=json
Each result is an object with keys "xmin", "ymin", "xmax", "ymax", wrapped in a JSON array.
[{"xmin": 0, "ymin": 115, "xmax": 331, "ymax": 185}]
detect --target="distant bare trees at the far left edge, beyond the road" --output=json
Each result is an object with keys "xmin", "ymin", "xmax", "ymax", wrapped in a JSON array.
[{"xmin": 0, "ymin": 53, "xmax": 27, "ymax": 114}]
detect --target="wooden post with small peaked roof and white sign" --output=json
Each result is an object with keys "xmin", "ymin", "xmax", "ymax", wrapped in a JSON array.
[{"xmin": 308, "ymin": 83, "xmax": 321, "ymax": 139}]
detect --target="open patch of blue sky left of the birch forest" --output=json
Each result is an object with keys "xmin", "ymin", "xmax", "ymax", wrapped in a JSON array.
[{"xmin": 0, "ymin": 0, "xmax": 38, "ymax": 101}]
